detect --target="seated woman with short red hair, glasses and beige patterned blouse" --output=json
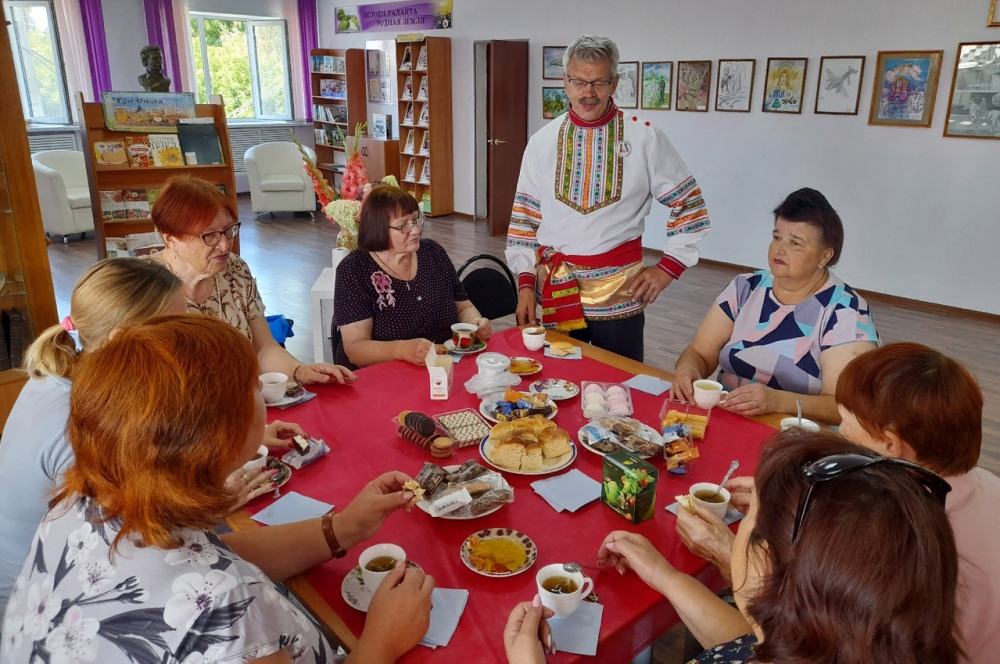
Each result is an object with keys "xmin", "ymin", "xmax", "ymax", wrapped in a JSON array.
[{"xmin": 151, "ymin": 175, "xmax": 356, "ymax": 384}]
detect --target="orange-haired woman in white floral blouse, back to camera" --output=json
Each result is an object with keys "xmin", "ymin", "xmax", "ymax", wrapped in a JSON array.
[{"xmin": 0, "ymin": 315, "xmax": 434, "ymax": 664}]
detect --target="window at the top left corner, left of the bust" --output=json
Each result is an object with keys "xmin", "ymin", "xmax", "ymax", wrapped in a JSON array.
[{"xmin": 3, "ymin": 0, "xmax": 70, "ymax": 124}]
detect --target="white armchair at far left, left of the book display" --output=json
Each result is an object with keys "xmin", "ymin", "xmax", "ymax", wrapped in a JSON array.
[{"xmin": 31, "ymin": 150, "xmax": 94, "ymax": 242}]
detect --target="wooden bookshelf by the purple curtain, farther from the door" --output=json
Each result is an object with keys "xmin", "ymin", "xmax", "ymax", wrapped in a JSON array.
[{"xmin": 309, "ymin": 48, "xmax": 368, "ymax": 185}]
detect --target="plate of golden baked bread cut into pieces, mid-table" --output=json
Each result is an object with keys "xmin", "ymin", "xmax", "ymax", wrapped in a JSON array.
[{"xmin": 479, "ymin": 415, "xmax": 577, "ymax": 475}]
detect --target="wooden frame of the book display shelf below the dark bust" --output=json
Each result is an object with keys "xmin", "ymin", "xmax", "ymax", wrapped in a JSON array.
[{"xmin": 76, "ymin": 93, "xmax": 240, "ymax": 260}]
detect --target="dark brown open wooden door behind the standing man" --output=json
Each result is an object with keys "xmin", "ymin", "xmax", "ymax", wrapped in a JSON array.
[{"xmin": 486, "ymin": 40, "xmax": 528, "ymax": 236}]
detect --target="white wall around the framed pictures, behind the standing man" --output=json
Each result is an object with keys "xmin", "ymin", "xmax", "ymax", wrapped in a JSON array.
[{"xmin": 319, "ymin": 0, "xmax": 1000, "ymax": 314}]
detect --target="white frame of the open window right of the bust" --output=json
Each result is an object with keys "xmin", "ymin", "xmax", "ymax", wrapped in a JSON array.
[{"xmin": 188, "ymin": 11, "xmax": 295, "ymax": 123}]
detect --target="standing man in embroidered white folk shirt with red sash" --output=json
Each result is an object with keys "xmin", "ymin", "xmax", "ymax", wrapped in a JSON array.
[{"xmin": 506, "ymin": 35, "xmax": 709, "ymax": 362}]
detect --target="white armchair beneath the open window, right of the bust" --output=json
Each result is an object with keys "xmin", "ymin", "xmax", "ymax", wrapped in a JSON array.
[{"xmin": 243, "ymin": 141, "xmax": 316, "ymax": 215}]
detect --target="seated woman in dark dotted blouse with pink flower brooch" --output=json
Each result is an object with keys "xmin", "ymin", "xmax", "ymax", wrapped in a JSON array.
[{"xmin": 333, "ymin": 186, "xmax": 492, "ymax": 368}]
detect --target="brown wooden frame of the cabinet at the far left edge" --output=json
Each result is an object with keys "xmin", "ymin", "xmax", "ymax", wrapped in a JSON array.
[{"xmin": 0, "ymin": 24, "xmax": 59, "ymax": 428}]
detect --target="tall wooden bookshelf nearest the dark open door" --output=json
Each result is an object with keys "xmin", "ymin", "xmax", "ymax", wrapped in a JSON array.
[{"xmin": 396, "ymin": 37, "xmax": 455, "ymax": 217}]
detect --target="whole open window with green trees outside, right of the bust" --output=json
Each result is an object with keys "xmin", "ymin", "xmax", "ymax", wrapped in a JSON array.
[{"xmin": 191, "ymin": 12, "xmax": 292, "ymax": 120}]
